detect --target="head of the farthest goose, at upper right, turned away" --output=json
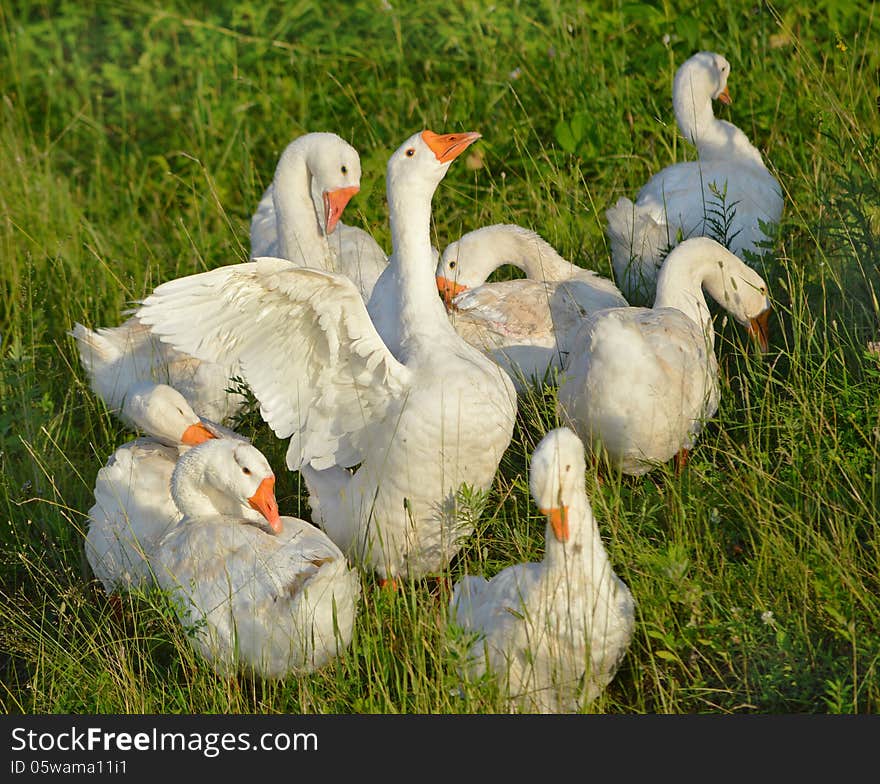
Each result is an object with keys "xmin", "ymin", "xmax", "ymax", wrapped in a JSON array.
[{"xmin": 672, "ymin": 52, "xmax": 731, "ymax": 144}]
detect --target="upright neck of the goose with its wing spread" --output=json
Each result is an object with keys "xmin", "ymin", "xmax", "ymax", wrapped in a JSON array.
[{"xmin": 388, "ymin": 183, "xmax": 455, "ymax": 350}]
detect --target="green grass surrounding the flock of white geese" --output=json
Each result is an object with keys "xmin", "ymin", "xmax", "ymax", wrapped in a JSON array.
[{"xmin": 0, "ymin": 0, "xmax": 880, "ymax": 713}]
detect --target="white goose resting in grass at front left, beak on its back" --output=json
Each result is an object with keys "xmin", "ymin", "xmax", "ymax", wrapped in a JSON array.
[{"xmin": 154, "ymin": 439, "xmax": 360, "ymax": 678}]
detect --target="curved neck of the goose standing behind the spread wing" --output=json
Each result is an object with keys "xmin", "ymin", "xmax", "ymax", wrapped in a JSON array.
[{"xmin": 273, "ymin": 143, "xmax": 330, "ymax": 269}]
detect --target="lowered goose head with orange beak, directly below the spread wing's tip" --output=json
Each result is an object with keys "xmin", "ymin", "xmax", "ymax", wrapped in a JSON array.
[{"xmin": 122, "ymin": 381, "xmax": 217, "ymax": 446}]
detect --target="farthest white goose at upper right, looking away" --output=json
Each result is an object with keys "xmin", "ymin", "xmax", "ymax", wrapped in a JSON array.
[{"xmin": 606, "ymin": 52, "xmax": 783, "ymax": 305}]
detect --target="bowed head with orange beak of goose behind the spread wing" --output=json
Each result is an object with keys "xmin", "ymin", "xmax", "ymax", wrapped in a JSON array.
[{"xmin": 276, "ymin": 133, "xmax": 361, "ymax": 234}]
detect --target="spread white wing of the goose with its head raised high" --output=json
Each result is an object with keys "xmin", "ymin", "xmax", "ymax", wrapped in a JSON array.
[{"xmin": 137, "ymin": 258, "xmax": 411, "ymax": 470}]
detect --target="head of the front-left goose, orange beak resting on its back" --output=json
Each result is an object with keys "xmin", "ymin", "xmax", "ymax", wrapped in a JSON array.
[{"xmin": 171, "ymin": 438, "xmax": 282, "ymax": 534}]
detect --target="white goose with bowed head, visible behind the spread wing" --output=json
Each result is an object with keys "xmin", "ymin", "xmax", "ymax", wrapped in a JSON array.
[{"xmin": 251, "ymin": 133, "xmax": 388, "ymax": 302}]
